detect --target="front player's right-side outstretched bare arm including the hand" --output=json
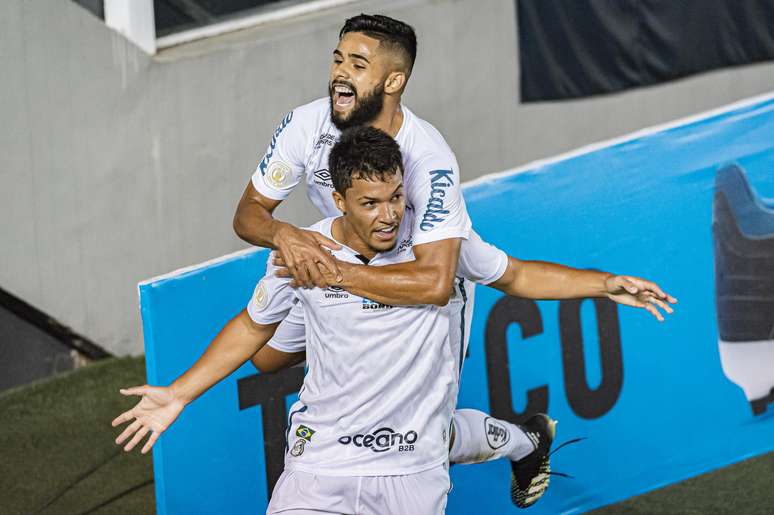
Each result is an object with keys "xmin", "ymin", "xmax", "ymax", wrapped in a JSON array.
[{"xmin": 490, "ymin": 257, "xmax": 677, "ymax": 321}]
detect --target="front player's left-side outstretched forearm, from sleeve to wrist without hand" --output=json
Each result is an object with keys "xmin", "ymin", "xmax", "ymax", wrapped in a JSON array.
[{"xmin": 171, "ymin": 311, "xmax": 277, "ymax": 404}]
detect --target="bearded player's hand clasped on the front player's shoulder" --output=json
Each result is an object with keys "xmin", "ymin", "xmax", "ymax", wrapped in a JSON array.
[{"xmin": 274, "ymin": 224, "xmax": 342, "ymax": 288}]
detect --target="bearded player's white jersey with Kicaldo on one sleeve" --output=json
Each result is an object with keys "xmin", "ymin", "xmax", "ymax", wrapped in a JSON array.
[{"xmin": 252, "ymin": 97, "xmax": 470, "ymax": 245}]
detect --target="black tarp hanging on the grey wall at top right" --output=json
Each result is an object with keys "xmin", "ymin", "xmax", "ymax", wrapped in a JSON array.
[{"xmin": 516, "ymin": 0, "xmax": 774, "ymax": 102}]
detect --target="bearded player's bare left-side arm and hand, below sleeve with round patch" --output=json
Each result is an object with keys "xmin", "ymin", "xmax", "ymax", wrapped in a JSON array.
[{"xmin": 234, "ymin": 182, "xmax": 341, "ymax": 288}]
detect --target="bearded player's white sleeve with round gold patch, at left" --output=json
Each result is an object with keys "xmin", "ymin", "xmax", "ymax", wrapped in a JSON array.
[{"xmin": 252, "ymin": 111, "xmax": 307, "ymax": 200}]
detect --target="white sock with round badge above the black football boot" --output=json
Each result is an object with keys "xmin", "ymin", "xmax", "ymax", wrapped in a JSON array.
[{"xmin": 449, "ymin": 409, "xmax": 535, "ymax": 463}]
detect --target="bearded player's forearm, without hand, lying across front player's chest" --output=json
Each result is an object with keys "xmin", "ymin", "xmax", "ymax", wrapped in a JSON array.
[{"xmin": 340, "ymin": 261, "xmax": 454, "ymax": 306}]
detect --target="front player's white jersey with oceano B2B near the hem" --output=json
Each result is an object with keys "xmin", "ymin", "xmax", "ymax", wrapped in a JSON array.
[{"xmin": 247, "ymin": 214, "xmax": 464, "ymax": 476}]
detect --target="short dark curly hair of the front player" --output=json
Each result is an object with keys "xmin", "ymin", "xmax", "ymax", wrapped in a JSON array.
[{"xmin": 328, "ymin": 126, "xmax": 403, "ymax": 195}]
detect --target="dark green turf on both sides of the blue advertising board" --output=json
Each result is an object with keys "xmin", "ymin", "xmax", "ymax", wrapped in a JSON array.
[{"xmin": 0, "ymin": 358, "xmax": 774, "ymax": 515}]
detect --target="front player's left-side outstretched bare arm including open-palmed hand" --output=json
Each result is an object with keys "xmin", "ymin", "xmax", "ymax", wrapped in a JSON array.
[{"xmin": 112, "ymin": 310, "xmax": 278, "ymax": 454}]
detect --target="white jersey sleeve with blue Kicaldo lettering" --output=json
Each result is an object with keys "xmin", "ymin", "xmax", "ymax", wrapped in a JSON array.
[{"xmin": 404, "ymin": 153, "xmax": 470, "ymax": 245}]
